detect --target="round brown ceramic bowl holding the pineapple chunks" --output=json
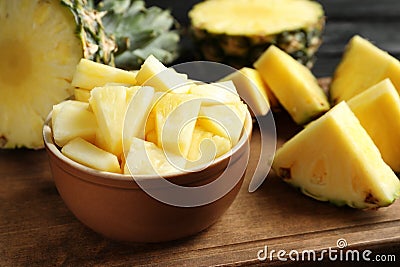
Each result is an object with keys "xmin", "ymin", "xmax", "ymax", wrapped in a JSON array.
[{"xmin": 43, "ymin": 110, "xmax": 252, "ymax": 242}]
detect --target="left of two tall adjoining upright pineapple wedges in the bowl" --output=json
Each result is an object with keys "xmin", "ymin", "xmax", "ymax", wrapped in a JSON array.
[{"xmin": 89, "ymin": 86, "xmax": 127, "ymax": 157}]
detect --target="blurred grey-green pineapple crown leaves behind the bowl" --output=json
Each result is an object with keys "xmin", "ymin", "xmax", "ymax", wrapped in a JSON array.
[{"xmin": 95, "ymin": 0, "xmax": 180, "ymax": 69}]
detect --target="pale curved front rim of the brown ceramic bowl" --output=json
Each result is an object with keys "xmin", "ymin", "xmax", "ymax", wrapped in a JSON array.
[{"xmin": 42, "ymin": 109, "xmax": 253, "ymax": 182}]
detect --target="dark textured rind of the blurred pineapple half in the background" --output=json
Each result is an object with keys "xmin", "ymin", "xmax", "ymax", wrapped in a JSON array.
[{"xmin": 191, "ymin": 1, "xmax": 325, "ymax": 69}]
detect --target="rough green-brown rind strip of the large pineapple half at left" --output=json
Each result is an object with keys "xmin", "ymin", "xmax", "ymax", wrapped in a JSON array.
[{"xmin": 61, "ymin": 0, "xmax": 117, "ymax": 65}]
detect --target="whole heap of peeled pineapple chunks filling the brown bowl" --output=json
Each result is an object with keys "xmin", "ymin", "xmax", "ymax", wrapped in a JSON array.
[{"xmin": 52, "ymin": 56, "xmax": 248, "ymax": 175}]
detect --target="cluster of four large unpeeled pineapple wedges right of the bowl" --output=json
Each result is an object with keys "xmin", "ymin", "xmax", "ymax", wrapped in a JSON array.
[{"xmin": 241, "ymin": 36, "xmax": 400, "ymax": 209}]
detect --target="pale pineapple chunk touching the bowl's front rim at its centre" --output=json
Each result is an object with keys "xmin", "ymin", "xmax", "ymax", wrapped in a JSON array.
[{"xmin": 124, "ymin": 137, "xmax": 179, "ymax": 175}]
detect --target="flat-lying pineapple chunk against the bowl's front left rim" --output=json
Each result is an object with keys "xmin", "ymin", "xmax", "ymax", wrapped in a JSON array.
[{"xmin": 61, "ymin": 137, "xmax": 121, "ymax": 173}]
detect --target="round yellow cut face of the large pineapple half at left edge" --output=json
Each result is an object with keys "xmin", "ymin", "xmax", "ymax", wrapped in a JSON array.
[{"xmin": 0, "ymin": 0, "xmax": 83, "ymax": 148}]
